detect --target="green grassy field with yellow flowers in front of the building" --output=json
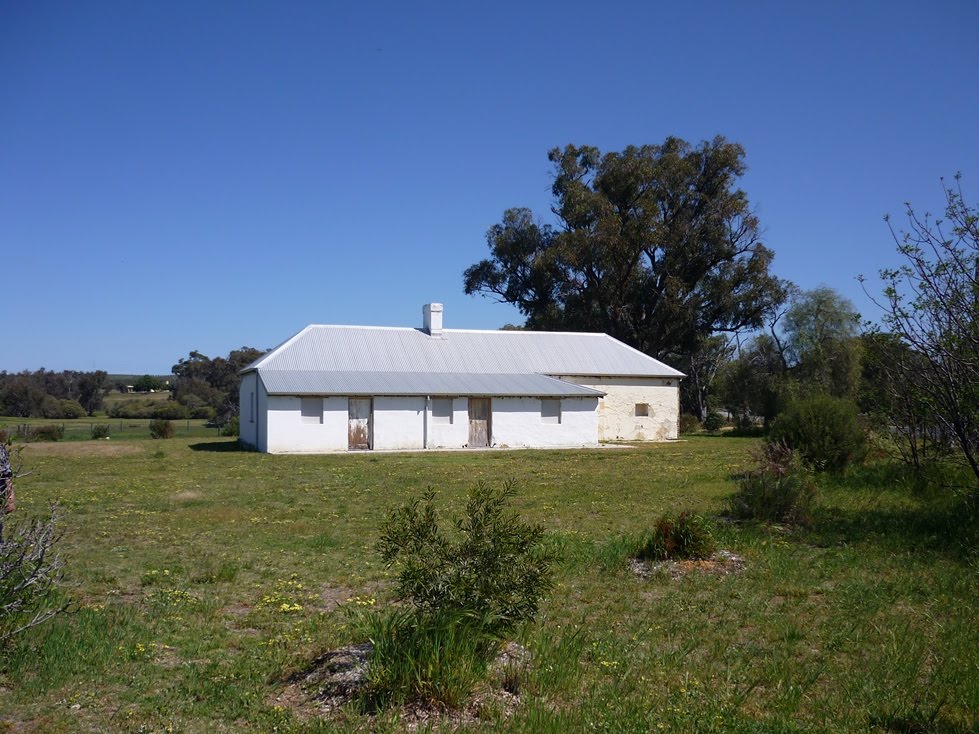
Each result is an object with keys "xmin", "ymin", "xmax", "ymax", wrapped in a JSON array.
[{"xmin": 0, "ymin": 437, "xmax": 979, "ymax": 732}]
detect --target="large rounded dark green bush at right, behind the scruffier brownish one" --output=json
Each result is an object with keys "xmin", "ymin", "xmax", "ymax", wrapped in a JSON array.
[{"xmin": 770, "ymin": 395, "xmax": 867, "ymax": 471}]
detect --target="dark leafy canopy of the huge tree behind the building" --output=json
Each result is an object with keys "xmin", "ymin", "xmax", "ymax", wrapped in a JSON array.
[{"xmin": 464, "ymin": 137, "xmax": 785, "ymax": 360}]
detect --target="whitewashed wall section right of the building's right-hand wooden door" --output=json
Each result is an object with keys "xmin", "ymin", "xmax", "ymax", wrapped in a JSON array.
[{"xmin": 490, "ymin": 398, "xmax": 598, "ymax": 448}]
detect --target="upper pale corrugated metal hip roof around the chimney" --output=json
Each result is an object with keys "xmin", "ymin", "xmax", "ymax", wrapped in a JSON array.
[{"xmin": 244, "ymin": 325, "xmax": 683, "ymax": 380}]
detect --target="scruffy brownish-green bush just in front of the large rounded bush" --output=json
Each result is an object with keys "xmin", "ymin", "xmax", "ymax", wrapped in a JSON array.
[{"xmin": 728, "ymin": 443, "xmax": 816, "ymax": 525}]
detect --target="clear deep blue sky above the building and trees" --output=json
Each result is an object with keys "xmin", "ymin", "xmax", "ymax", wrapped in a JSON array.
[{"xmin": 0, "ymin": 0, "xmax": 979, "ymax": 373}]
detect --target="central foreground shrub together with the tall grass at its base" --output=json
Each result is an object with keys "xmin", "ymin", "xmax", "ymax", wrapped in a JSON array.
[{"xmin": 355, "ymin": 481, "xmax": 554, "ymax": 710}]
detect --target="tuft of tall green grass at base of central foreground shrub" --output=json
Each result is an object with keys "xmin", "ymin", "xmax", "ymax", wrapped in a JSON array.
[{"xmin": 359, "ymin": 608, "xmax": 499, "ymax": 711}]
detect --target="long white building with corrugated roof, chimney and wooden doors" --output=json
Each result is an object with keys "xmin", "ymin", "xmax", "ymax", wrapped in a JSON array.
[{"xmin": 240, "ymin": 303, "xmax": 683, "ymax": 453}]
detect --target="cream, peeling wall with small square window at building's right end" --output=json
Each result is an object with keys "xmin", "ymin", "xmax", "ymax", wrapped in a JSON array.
[{"xmin": 561, "ymin": 376, "xmax": 680, "ymax": 441}]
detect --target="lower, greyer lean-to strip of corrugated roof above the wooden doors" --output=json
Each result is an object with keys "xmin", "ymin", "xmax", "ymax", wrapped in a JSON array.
[{"xmin": 259, "ymin": 367, "xmax": 604, "ymax": 398}]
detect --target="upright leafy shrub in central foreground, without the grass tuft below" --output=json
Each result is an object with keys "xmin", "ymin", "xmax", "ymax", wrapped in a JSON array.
[{"xmin": 377, "ymin": 480, "xmax": 554, "ymax": 636}]
